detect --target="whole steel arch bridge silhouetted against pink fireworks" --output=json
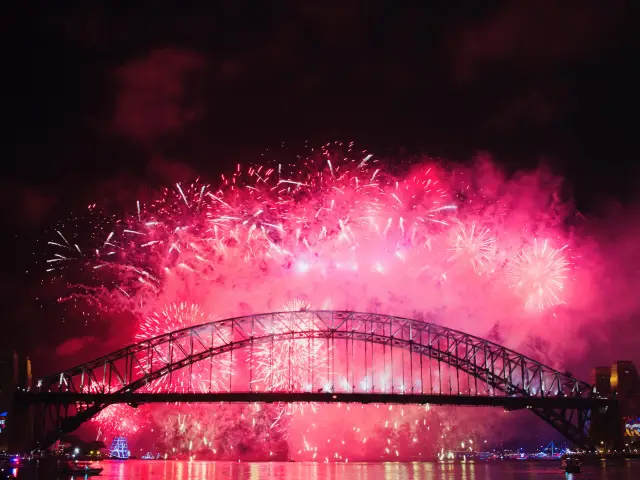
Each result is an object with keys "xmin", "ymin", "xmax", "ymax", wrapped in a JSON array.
[{"xmin": 7, "ymin": 310, "xmax": 622, "ymax": 449}]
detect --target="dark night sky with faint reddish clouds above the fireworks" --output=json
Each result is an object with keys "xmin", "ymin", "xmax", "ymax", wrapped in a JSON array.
[{"xmin": 1, "ymin": 0, "xmax": 640, "ymax": 366}]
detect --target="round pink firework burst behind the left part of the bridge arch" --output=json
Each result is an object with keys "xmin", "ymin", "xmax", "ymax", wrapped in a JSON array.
[{"xmin": 136, "ymin": 302, "xmax": 231, "ymax": 393}]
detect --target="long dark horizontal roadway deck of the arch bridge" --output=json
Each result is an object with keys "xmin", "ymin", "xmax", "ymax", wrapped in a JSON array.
[{"xmin": 15, "ymin": 391, "xmax": 611, "ymax": 410}]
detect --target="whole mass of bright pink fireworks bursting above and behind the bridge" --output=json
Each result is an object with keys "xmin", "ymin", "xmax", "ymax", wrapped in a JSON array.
[{"xmin": 45, "ymin": 145, "xmax": 577, "ymax": 460}]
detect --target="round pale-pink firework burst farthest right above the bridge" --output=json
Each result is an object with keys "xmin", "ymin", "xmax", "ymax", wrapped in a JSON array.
[{"xmin": 509, "ymin": 239, "xmax": 570, "ymax": 310}]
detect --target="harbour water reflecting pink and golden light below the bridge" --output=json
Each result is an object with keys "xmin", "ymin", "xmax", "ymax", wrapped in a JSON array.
[{"xmin": 6, "ymin": 460, "xmax": 640, "ymax": 480}]
